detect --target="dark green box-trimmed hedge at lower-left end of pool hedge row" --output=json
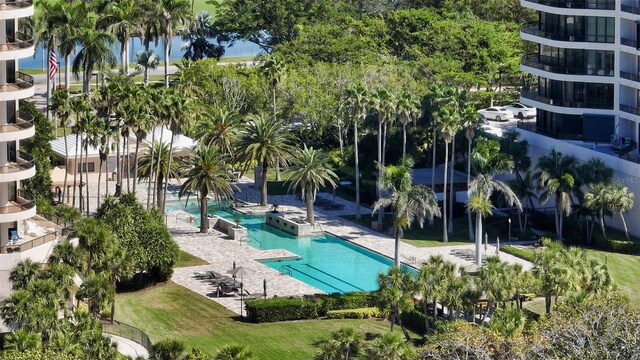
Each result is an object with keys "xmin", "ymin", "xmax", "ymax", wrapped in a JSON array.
[{"xmin": 246, "ymin": 298, "xmax": 318, "ymax": 323}]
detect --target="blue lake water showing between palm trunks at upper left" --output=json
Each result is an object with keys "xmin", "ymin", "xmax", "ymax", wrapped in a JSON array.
[{"xmin": 20, "ymin": 36, "xmax": 261, "ymax": 69}]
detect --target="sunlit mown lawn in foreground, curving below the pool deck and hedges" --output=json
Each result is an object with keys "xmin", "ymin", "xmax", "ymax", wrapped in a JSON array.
[{"xmin": 116, "ymin": 284, "xmax": 399, "ymax": 359}]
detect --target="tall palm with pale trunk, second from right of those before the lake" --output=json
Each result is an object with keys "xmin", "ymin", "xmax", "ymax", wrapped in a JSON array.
[{"xmin": 96, "ymin": 0, "xmax": 143, "ymax": 74}]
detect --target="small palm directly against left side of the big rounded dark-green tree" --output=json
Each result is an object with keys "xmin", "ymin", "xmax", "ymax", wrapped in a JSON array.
[{"xmin": 76, "ymin": 217, "xmax": 114, "ymax": 275}]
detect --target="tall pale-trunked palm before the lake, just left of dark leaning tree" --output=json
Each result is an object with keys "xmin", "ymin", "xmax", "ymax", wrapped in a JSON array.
[{"xmin": 155, "ymin": 0, "xmax": 193, "ymax": 87}]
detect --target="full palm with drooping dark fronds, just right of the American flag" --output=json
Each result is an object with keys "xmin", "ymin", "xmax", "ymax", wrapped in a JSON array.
[{"xmin": 67, "ymin": 28, "xmax": 117, "ymax": 93}]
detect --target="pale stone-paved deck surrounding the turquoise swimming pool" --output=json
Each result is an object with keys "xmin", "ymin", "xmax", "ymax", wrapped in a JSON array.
[{"xmin": 159, "ymin": 179, "xmax": 532, "ymax": 314}]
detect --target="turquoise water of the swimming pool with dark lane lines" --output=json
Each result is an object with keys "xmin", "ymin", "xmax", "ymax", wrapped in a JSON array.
[{"xmin": 167, "ymin": 202, "xmax": 413, "ymax": 293}]
